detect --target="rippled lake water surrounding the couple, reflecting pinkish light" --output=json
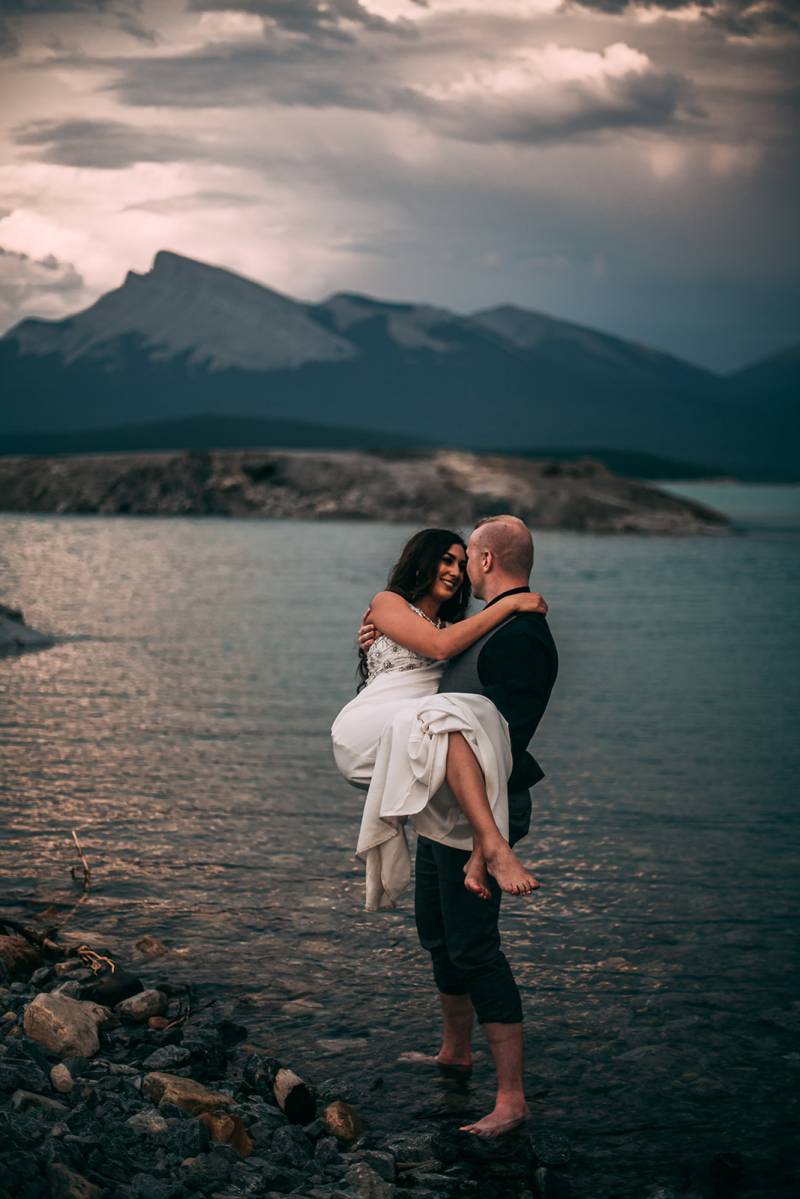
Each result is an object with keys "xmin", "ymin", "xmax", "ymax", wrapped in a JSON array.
[{"xmin": 0, "ymin": 517, "xmax": 800, "ymax": 1197}]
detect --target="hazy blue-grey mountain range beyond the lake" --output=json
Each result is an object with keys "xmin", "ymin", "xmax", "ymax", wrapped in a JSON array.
[{"xmin": 0, "ymin": 251, "xmax": 800, "ymax": 480}]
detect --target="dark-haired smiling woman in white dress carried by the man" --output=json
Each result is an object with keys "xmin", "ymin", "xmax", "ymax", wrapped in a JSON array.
[{"xmin": 331, "ymin": 529, "xmax": 547, "ymax": 910}]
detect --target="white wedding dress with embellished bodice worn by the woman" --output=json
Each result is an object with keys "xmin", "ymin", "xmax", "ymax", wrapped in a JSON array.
[{"xmin": 331, "ymin": 604, "xmax": 511, "ymax": 911}]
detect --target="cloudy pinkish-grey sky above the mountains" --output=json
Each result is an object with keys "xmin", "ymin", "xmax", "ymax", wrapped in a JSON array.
[{"xmin": 0, "ymin": 0, "xmax": 800, "ymax": 372}]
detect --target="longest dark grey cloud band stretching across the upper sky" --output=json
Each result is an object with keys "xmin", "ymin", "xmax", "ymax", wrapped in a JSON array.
[{"xmin": 87, "ymin": 35, "xmax": 703, "ymax": 145}]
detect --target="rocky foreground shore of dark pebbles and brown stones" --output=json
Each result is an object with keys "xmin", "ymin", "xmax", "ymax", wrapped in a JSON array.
[{"xmin": 0, "ymin": 918, "xmax": 571, "ymax": 1199}]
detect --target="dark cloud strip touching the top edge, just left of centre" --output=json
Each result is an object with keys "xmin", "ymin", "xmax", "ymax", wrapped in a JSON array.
[{"xmin": 188, "ymin": 0, "xmax": 410, "ymax": 41}]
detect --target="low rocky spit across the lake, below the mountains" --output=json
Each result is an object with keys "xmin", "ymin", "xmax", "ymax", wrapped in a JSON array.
[{"xmin": 0, "ymin": 450, "xmax": 729, "ymax": 535}]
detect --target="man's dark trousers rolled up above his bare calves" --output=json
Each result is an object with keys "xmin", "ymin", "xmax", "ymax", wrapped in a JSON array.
[{"xmin": 414, "ymin": 837, "xmax": 522, "ymax": 1024}]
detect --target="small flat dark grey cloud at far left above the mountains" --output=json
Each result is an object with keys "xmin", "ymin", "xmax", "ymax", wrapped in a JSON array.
[{"xmin": 12, "ymin": 120, "xmax": 205, "ymax": 170}]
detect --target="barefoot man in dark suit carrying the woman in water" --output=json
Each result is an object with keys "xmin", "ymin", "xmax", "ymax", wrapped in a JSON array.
[{"xmin": 359, "ymin": 516, "xmax": 558, "ymax": 1137}]
